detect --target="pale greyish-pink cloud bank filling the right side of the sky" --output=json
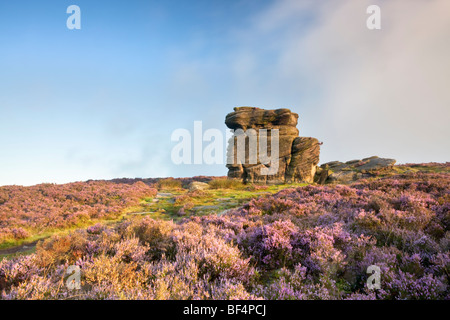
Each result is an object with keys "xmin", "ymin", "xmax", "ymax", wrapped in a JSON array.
[{"xmin": 227, "ymin": 0, "xmax": 450, "ymax": 162}]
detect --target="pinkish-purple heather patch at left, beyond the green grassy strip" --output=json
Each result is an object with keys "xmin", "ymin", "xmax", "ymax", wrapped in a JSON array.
[{"xmin": 0, "ymin": 181, "xmax": 156, "ymax": 244}]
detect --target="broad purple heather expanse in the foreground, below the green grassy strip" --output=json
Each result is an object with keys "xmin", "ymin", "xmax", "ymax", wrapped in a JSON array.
[{"xmin": 0, "ymin": 173, "xmax": 450, "ymax": 299}]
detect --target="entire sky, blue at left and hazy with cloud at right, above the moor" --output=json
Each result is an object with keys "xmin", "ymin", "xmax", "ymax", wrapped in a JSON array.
[{"xmin": 0, "ymin": 0, "xmax": 450, "ymax": 185}]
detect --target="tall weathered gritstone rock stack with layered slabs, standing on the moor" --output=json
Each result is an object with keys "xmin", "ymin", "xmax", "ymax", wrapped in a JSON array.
[{"xmin": 225, "ymin": 107, "xmax": 320, "ymax": 184}]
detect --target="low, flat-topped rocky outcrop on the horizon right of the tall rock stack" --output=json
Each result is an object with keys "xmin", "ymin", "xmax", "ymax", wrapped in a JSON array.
[{"xmin": 314, "ymin": 156, "xmax": 396, "ymax": 184}]
